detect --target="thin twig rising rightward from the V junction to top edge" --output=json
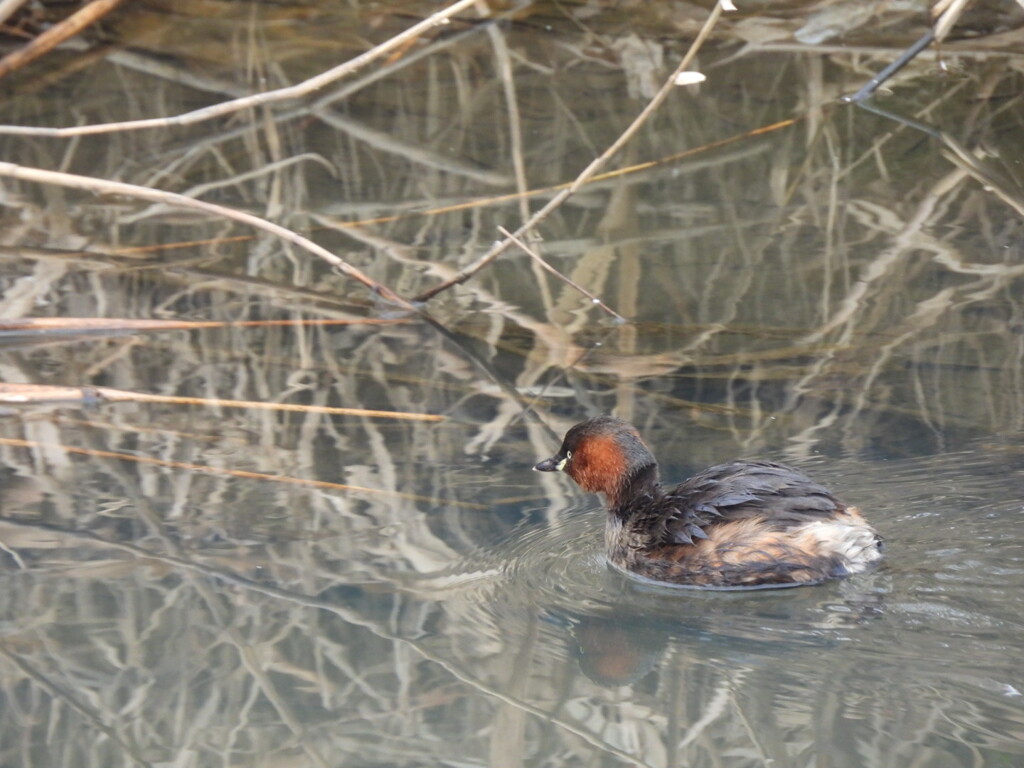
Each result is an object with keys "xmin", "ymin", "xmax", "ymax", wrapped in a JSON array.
[{"xmin": 416, "ymin": 3, "xmax": 722, "ymax": 301}]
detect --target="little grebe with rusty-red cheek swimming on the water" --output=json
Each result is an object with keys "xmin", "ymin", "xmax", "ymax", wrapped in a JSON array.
[{"xmin": 534, "ymin": 416, "xmax": 882, "ymax": 587}]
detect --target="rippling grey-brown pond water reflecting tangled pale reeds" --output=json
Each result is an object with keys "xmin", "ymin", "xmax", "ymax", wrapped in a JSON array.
[{"xmin": 0, "ymin": 0, "xmax": 1024, "ymax": 768}]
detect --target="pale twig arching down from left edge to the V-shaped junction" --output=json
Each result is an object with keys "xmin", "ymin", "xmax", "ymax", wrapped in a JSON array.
[{"xmin": 0, "ymin": 162, "xmax": 418, "ymax": 312}]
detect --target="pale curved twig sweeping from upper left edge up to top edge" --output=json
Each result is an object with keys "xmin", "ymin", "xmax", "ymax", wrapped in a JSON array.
[{"xmin": 0, "ymin": 0, "xmax": 477, "ymax": 138}]
